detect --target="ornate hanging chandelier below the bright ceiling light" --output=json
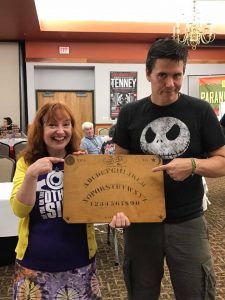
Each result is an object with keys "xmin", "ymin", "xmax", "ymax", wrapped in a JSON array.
[{"xmin": 173, "ymin": 0, "xmax": 215, "ymax": 50}]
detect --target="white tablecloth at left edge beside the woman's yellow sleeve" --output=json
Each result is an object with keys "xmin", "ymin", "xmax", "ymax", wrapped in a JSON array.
[{"xmin": 0, "ymin": 182, "xmax": 19, "ymax": 237}]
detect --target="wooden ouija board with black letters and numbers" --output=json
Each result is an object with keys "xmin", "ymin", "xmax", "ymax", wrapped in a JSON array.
[{"xmin": 63, "ymin": 155, "xmax": 165, "ymax": 223}]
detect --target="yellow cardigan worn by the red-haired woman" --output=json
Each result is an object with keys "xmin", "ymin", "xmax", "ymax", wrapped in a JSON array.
[{"xmin": 10, "ymin": 157, "xmax": 97, "ymax": 260}]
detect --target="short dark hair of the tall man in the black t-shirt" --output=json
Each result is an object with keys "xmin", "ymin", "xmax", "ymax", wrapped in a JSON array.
[{"xmin": 146, "ymin": 38, "xmax": 188, "ymax": 72}]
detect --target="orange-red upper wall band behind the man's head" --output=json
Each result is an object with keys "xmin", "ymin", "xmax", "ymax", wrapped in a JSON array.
[{"xmin": 26, "ymin": 42, "xmax": 225, "ymax": 63}]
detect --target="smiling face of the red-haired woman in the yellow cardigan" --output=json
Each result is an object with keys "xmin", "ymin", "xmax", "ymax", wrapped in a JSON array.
[{"xmin": 44, "ymin": 111, "xmax": 73, "ymax": 158}]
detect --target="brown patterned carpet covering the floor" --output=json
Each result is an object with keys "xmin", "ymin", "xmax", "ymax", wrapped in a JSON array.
[{"xmin": 0, "ymin": 177, "xmax": 225, "ymax": 300}]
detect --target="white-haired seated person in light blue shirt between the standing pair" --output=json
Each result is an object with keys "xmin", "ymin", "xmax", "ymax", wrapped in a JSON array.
[{"xmin": 80, "ymin": 122, "xmax": 105, "ymax": 154}]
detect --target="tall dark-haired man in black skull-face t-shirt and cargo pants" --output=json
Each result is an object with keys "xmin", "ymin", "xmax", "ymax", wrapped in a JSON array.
[{"xmin": 110, "ymin": 39, "xmax": 225, "ymax": 300}]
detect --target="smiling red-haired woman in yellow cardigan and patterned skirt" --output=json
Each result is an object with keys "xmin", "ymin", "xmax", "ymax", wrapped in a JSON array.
[{"xmin": 11, "ymin": 102, "xmax": 101, "ymax": 300}]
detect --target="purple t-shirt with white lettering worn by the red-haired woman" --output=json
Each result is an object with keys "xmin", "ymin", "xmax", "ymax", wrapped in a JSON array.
[{"xmin": 19, "ymin": 163, "xmax": 91, "ymax": 272}]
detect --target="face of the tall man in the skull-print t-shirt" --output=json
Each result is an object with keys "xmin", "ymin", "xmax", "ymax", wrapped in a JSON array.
[{"xmin": 146, "ymin": 58, "xmax": 184, "ymax": 106}]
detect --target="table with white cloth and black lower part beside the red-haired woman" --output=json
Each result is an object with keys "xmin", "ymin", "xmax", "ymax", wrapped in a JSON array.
[{"xmin": 0, "ymin": 182, "xmax": 19, "ymax": 266}]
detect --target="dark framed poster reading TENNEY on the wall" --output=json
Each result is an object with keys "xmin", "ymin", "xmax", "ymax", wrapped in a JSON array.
[{"xmin": 110, "ymin": 71, "xmax": 137, "ymax": 119}]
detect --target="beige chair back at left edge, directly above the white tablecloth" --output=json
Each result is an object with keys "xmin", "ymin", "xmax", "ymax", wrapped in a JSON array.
[{"xmin": 0, "ymin": 155, "xmax": 16, "ymax": 182}]
